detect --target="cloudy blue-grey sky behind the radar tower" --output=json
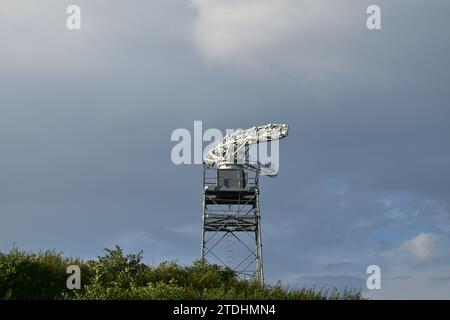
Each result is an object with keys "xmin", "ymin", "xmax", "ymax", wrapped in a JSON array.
[{"xmin": 0, "ymin": 0, "xmax": 450, "ymax": 299}]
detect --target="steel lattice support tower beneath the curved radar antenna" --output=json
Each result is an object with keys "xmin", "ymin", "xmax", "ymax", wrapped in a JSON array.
[{"xmin": 201, "ymin": 166, "xmax": 264, "ymax": 282}]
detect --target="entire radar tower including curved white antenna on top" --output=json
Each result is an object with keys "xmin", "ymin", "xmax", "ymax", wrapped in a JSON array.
[{"xmin": 201, "ymin": 124, "xmax": 288, "ymax": 283}]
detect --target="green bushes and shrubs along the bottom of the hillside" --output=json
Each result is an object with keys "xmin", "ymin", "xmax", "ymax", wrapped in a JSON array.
[{"xmin": 0, "ymin": 247, "xmax": 362, "ymax": 300}]
